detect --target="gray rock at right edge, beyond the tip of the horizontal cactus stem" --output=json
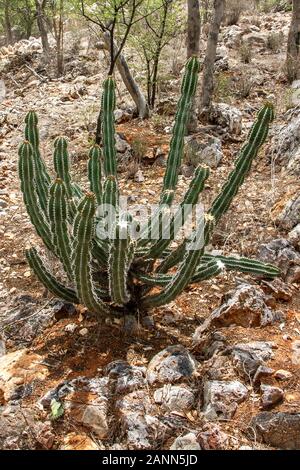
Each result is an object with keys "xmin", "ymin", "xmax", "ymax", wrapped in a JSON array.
[{"xmin": 258, "ymin": 238, "xmax": 300, "ymax": 283}]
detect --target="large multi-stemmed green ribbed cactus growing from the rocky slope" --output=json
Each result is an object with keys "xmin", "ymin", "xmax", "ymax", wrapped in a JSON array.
[{"xmin": 19, "ymin": 57, "xmax": 279, "ymax": 315}]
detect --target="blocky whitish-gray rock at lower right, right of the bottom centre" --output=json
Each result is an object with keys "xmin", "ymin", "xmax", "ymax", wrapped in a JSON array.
[{"xmin": 203, "ymin": 380, "xmax": 248, "ymax": 421}]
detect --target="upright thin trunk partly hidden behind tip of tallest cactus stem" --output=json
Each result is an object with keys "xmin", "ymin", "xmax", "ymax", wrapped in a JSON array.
[{"xmin": 187, "ymin": 0, "xmax": 201, "ymax": 133}]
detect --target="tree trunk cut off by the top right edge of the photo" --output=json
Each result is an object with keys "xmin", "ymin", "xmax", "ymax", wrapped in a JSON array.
[{"xmin": 286, "ymin": 0, "xmax": 300, "ymax": 82}]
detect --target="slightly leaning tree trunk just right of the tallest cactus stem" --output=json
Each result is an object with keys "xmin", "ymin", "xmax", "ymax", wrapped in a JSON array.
[{"xmin": 199, "ymin": 0, "xmax": 225, "ymax": 120}]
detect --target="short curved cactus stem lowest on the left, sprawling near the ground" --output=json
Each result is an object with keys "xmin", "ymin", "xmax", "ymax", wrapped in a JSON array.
[{"xmin": 25, "ymin": 248, "xmax": 79, "ymax": 304}]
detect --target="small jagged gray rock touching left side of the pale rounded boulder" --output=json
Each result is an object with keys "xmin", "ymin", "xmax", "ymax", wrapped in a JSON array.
[{"xmin": 105, "ymin": 360, "xmax": 146, "ymax": 394}]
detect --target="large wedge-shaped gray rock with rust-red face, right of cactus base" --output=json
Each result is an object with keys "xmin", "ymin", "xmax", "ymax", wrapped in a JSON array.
[{"xmin": 193, "ymin": 284, "xmax": 282, "ymax": 336}]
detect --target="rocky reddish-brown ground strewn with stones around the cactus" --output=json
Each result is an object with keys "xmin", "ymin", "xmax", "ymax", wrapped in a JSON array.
[{"xmin": 0, "ymin": 13, "xmax": 300, "ymax": 449}]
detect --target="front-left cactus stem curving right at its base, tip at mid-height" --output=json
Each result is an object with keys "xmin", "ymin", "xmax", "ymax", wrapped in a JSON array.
[{"xmin": 73, "ymin": 193, "xmax": 109, "ymax": 314}]
